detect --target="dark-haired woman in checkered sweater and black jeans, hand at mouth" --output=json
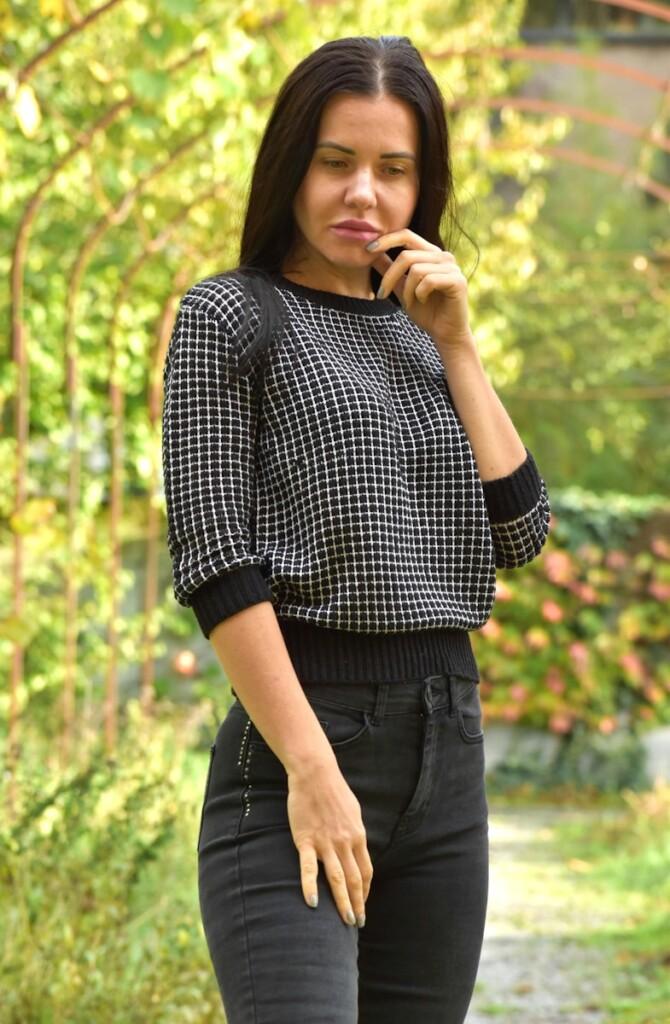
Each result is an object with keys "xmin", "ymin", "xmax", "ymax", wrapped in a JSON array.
[{"xmin": 163, "ymin": 37, "xmax": 549, "ymax": 1024}]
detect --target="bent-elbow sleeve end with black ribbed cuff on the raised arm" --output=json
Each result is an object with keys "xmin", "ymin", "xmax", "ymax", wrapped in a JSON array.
[{"xmin": 483, "ymin": 449, "xmax": 551, "ymax": 569}]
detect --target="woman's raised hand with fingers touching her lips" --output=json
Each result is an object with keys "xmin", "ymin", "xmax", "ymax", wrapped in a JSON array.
[{"xmin": 366, "ymin": 227, "xmax": 473, "ymax": 348}]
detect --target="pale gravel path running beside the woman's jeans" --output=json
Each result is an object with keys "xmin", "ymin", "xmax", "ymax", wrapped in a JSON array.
[{"xmin": 466, "ymin": 801, "xmax": 624, "ymax": 1024}]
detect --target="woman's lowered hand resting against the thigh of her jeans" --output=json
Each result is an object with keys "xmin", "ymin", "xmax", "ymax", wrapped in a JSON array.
[{"xmin": 287, "ymin": 764, "xmax": 373, "ymax": 927}]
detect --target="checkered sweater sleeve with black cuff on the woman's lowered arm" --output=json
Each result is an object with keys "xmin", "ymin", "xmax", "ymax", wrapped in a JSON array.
[{"xmin": 162, "ymin": 286, "xmax": 270, "ymax": 637}]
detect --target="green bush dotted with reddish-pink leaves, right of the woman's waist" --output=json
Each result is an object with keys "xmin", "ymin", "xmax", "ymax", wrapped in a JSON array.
[{"xmin": 474, "ymin": 492, "xmax": 670, "ymax": 737}]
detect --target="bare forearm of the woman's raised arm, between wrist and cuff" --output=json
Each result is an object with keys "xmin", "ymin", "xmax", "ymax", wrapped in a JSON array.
[{"xmin": 436, "ymin": 338, "xmax": 526, "ymax": 481}]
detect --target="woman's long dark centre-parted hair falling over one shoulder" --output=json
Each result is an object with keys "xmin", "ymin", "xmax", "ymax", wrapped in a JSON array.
[{"xmin": 208, "ymin": 36, "xmax": 478, "ymax": 382}]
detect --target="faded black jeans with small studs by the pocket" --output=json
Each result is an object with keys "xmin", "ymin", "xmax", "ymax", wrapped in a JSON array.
[{"xmin": 198, "ymin": 675, "xmax": 489, "ymax": 1024}]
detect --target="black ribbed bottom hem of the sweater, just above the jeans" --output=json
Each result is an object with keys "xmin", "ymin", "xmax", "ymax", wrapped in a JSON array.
[{"xmin": 278, "ymin": 616, "xmax": 479, "ymax": 685}]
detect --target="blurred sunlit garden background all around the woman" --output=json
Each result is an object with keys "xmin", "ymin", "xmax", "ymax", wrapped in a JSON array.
[{"xmin": 0, "ymin": 0, "xmax": 670, "ymax": 1024}]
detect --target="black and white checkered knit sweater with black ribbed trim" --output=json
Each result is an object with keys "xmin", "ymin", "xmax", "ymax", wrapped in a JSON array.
[{"xmin": 162, "ymin": 274, "xmax": 549, "ymax": 683}]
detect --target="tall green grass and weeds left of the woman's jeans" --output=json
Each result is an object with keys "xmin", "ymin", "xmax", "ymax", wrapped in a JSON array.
[{"xmin": 0, "ymin": 702, "xmax": 220, "ymax": 1024}]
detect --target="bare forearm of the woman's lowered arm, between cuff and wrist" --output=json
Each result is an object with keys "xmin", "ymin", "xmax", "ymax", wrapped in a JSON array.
[{"xmin": 209, "ymin": 601, "xmax": 336, "ymax": 774}]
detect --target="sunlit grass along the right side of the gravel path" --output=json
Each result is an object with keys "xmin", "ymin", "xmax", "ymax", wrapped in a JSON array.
[{"xmin": 483, "ymin": 779, "xmax": 670, "ymax": 1024}]
